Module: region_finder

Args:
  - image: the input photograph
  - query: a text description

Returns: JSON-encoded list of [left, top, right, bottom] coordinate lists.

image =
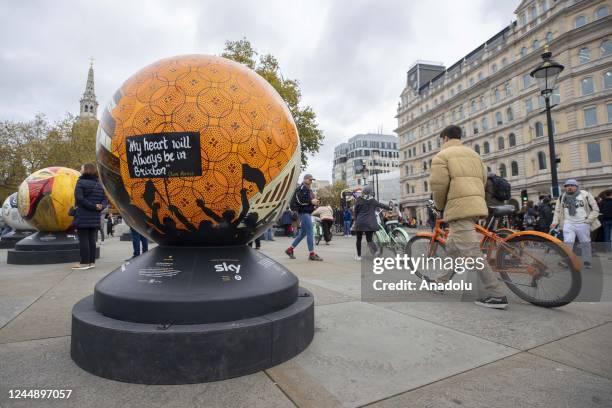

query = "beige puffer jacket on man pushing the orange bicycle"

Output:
[[429, 139, 488, 222]]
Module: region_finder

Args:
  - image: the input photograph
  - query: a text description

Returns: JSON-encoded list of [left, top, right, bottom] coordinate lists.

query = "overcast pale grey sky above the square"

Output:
[[0, 0, 519, 179]]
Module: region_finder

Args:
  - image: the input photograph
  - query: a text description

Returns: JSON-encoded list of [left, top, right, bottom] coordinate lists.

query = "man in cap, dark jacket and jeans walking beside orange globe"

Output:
[[285, 174, 323, 261]]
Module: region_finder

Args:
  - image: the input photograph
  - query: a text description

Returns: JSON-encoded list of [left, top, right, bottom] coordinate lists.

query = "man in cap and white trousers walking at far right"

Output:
[[551, 179, 601, 269]]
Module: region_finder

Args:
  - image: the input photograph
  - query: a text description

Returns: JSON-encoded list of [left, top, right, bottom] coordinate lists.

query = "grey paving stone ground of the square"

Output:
[[0, 233, 612, 408]]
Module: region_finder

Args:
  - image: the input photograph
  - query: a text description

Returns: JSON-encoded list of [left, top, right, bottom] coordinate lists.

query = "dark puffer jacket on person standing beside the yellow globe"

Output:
[[72, 174, 108, 229]]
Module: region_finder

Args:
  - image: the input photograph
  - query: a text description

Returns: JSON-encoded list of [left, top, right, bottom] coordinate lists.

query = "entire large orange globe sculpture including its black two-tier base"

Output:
[[72, 55, 314, 384]]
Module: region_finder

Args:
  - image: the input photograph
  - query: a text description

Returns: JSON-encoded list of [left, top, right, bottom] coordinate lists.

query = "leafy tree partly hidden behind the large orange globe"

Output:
[[221, 38, 324, 168]]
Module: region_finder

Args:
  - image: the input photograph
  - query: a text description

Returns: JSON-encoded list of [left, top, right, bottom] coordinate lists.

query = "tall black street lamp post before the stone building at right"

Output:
[[530, 46, 564, 198]]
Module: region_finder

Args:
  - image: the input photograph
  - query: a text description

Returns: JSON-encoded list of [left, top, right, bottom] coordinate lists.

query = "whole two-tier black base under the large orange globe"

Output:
[[71, 245, 314, 384]]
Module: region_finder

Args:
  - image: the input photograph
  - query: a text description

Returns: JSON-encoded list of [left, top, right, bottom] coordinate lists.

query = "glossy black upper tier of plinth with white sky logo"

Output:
[[94, 245, 298, 324]]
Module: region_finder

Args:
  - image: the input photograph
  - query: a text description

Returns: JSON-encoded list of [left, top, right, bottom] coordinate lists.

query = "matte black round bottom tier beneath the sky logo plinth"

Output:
[[70, 289, 314, 384]]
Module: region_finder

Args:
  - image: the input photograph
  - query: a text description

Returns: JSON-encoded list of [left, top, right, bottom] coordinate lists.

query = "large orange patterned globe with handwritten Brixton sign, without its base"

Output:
[[97, 55, 301, 246]]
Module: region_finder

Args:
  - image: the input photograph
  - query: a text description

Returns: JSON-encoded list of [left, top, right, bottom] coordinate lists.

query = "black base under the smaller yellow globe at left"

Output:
[[6, 231, 100, 265]]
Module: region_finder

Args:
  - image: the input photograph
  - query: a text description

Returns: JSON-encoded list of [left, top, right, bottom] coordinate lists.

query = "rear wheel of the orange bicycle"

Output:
[[495, 234, 582, 307]]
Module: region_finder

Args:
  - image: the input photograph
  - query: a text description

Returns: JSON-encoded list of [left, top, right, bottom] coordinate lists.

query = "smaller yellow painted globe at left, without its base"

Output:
[[17, 167, 81, 232]]
